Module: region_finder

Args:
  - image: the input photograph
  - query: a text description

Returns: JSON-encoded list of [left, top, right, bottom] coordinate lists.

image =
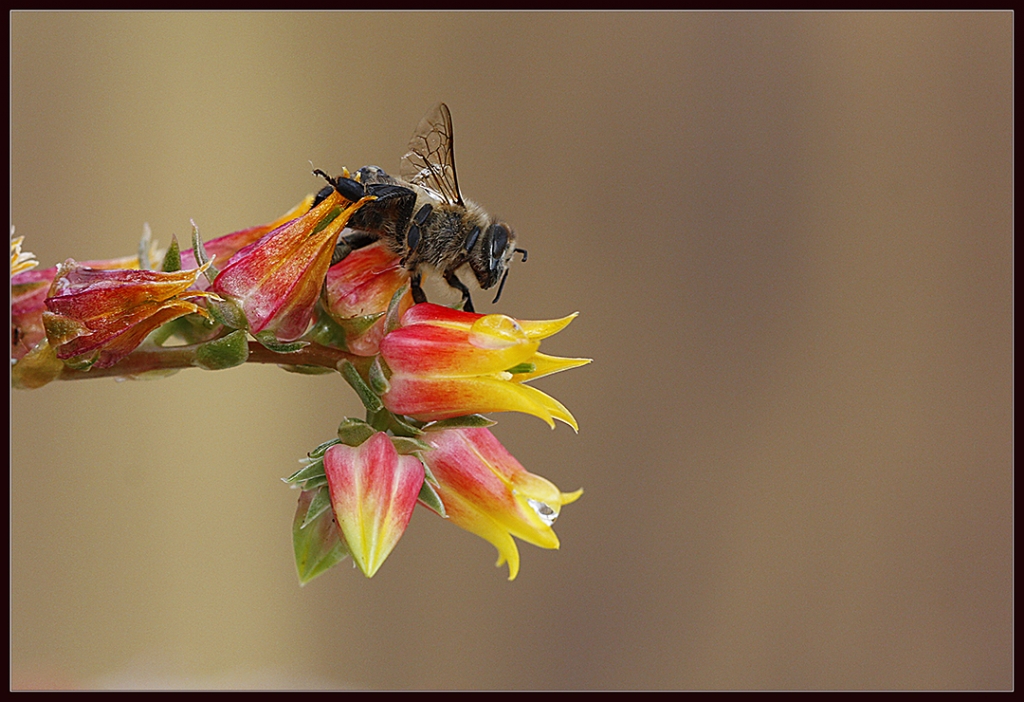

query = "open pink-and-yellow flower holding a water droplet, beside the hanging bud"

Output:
[[421, 427, 583, 580]]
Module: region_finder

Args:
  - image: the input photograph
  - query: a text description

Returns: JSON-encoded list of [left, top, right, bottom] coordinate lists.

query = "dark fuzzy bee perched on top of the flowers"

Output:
[[313, 102, 526, 312]]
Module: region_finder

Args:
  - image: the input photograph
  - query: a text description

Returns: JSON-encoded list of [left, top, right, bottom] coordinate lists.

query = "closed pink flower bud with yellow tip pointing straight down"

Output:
[[324, 432, 425, 577]]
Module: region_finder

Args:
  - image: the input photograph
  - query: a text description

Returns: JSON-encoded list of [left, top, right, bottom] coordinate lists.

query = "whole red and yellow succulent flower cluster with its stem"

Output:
[[11, 180, 589, 583]]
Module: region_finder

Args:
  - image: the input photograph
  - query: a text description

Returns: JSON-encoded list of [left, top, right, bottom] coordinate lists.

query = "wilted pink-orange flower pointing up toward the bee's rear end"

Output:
[[210, 191, 365, 343]]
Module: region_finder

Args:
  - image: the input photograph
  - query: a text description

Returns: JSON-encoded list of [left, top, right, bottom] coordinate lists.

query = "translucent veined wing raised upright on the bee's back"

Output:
[[400, 102, 464, 206]]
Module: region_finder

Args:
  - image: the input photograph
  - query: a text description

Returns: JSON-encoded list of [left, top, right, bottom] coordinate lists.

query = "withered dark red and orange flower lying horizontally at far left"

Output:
[[42, 259, 217, 368]]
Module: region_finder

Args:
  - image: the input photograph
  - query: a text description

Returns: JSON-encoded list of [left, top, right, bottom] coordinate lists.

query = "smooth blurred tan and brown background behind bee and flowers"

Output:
[[10, 12, 1014, 689]]
